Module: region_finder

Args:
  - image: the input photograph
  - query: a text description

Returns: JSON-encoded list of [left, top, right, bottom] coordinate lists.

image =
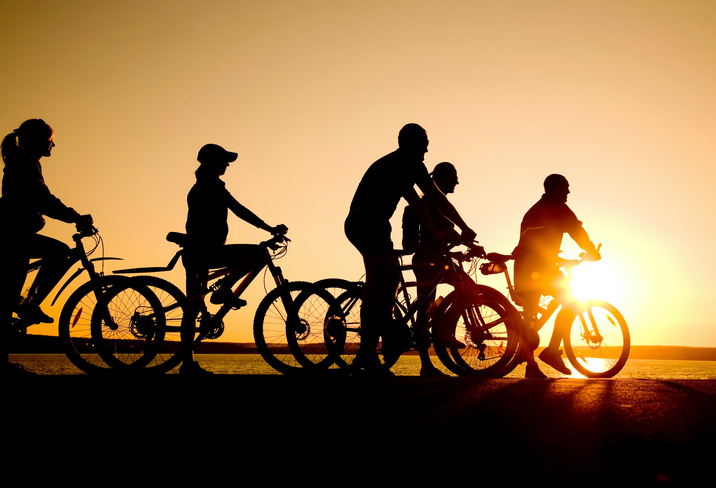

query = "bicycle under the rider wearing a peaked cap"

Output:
[[107, 232, 338, 374]]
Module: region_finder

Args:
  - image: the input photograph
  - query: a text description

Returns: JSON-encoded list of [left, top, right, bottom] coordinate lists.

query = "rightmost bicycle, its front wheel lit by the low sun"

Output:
[[480, 244, 631, 378]]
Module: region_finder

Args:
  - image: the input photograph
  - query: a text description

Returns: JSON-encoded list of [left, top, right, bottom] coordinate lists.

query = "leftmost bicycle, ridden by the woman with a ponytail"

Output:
[[13, 224, 165, 373]]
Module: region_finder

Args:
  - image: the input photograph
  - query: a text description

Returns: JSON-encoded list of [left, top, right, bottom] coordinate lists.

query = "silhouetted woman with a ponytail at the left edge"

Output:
[[0, 119, 92, 374]]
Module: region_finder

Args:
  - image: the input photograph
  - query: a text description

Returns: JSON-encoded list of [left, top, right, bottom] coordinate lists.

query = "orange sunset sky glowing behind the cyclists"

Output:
[[0, 0, 716, 347]]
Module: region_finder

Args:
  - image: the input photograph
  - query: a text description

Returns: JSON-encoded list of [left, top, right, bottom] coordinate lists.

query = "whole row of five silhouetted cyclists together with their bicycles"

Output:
[[0, 119, 630, 378]]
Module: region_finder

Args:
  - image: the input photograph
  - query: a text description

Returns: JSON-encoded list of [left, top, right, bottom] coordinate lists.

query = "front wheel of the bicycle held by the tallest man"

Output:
[[433, 285, 518, 378]]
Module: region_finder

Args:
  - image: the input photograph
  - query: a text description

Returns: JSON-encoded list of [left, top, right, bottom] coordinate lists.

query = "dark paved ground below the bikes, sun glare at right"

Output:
[[2, 375, 716, 487]]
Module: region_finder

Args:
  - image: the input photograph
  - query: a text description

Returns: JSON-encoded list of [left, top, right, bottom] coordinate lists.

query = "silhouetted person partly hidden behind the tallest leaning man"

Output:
[[403, 162, 458, 376]]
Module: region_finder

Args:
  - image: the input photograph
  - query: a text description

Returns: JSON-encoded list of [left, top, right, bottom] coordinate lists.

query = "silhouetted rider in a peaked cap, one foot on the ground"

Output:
[[180, 144, 288, 374]]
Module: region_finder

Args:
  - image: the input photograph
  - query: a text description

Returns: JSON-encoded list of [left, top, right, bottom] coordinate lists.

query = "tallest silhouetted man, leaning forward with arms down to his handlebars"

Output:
[[345, 124, 475, 375]]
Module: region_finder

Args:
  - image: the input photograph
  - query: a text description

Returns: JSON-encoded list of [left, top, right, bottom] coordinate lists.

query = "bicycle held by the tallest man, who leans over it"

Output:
[[296, 241, 518, 377]]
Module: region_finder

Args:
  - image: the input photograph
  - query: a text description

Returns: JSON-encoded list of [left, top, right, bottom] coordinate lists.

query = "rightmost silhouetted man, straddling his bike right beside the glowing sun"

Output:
[[512, 174, 601, 378]]
